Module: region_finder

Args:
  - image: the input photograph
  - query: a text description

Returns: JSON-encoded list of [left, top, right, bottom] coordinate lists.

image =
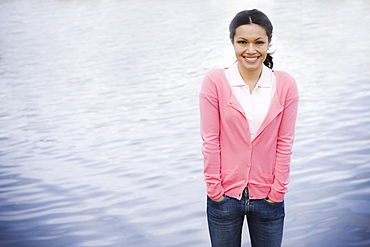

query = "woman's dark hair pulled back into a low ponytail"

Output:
[[229, 9, 274, 69]]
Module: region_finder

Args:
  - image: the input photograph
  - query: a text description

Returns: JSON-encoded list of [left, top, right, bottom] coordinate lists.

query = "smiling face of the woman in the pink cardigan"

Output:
[[233, 24, 270, 73]]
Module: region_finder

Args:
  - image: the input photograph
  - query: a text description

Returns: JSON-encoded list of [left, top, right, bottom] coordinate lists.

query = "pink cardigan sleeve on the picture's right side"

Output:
[[268, 76, 298, 202]]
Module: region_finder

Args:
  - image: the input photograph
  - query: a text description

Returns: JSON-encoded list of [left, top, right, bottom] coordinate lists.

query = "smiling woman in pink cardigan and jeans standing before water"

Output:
[[200, 9, 298, 247]]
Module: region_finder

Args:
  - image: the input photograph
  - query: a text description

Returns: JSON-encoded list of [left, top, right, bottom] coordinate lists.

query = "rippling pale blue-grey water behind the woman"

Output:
[[0, 0, 370, 247]]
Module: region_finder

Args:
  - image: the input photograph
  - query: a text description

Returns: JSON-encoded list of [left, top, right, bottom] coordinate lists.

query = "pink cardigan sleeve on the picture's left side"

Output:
[[199, 72, 224, 199]]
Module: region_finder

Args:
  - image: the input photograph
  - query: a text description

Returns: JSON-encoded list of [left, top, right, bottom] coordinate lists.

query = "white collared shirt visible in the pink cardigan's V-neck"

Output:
[[225, 62, 276, 141]]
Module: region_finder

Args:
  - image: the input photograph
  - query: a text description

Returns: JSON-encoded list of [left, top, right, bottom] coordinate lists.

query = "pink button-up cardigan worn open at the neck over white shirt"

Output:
[[200, 69, 298, 202]]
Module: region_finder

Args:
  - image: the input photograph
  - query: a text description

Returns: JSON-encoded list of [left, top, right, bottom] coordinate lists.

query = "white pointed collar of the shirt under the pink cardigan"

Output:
[[229, 62, 273, 88]]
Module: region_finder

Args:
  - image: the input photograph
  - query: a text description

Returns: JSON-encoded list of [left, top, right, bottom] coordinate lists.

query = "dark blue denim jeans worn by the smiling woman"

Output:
[[207, 189, 285, 247]]
